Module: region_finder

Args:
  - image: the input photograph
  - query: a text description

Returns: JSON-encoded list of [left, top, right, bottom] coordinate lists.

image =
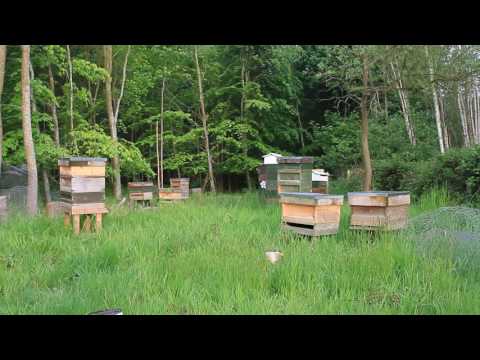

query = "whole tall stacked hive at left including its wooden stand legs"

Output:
[[58, 157, 108, 235]]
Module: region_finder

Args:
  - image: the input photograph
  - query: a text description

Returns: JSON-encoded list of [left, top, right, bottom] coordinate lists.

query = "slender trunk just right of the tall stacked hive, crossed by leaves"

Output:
[[103, 45, 122, 200]]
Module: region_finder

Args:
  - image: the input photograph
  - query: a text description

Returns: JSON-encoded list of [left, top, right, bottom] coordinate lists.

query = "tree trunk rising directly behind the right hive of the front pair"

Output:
[[360, 55, 372, 191]]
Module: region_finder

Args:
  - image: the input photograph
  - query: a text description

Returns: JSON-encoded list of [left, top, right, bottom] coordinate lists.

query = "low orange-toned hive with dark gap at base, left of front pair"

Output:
[[280, 192, 343, 236]]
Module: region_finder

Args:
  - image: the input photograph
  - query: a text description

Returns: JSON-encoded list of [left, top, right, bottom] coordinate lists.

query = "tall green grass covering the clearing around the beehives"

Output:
[[0, 190, 480, 314]]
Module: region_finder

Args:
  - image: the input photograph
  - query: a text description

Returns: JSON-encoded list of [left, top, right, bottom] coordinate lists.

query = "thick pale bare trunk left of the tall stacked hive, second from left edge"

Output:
[[21, 45, 38, 216]]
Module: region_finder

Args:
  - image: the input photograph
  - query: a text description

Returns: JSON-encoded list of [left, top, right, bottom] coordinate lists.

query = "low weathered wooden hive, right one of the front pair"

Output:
[[348, 191, 410, 230]]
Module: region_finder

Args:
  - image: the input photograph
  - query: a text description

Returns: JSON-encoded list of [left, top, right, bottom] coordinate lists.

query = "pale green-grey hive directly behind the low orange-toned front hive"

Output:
[[277, 156, 313, 193]]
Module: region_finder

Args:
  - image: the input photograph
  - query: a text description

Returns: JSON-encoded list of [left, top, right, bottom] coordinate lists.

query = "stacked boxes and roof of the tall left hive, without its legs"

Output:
[[58, 157, 107, 215]]
